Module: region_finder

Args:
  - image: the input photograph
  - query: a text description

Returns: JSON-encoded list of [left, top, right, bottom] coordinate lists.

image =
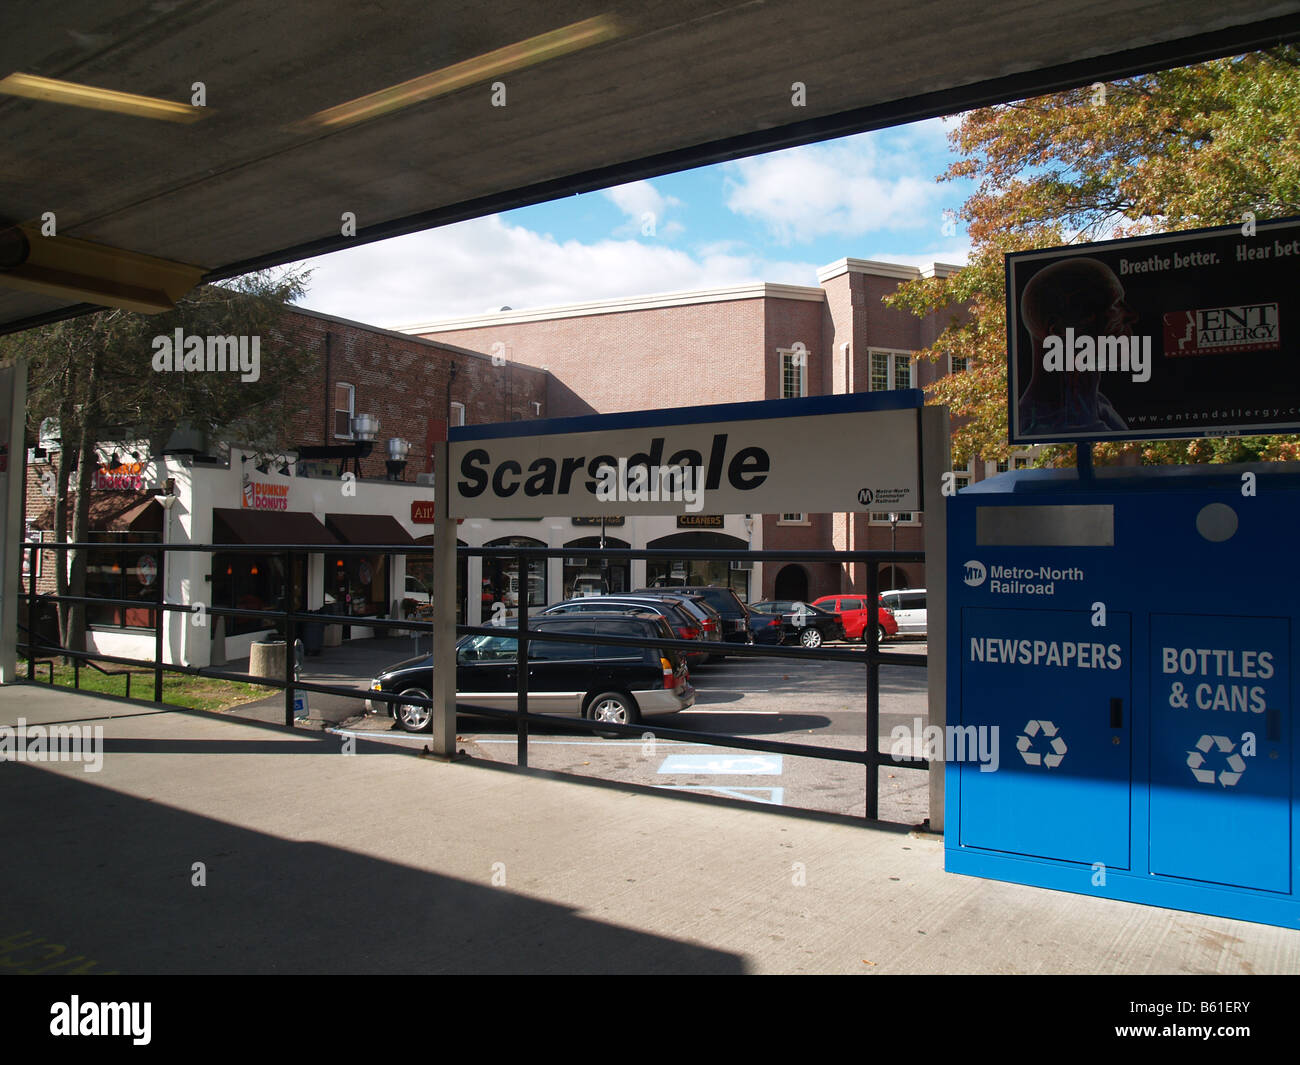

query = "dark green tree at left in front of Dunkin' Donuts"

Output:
[[0, 270, 313, 650]]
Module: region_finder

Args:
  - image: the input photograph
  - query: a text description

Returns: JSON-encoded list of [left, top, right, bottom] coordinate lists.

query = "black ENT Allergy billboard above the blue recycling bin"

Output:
[[1006, 218, 1300, 445]]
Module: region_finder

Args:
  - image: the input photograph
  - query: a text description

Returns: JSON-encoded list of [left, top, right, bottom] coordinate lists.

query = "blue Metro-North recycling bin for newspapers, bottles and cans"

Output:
[[945, 463, 1300, 927]]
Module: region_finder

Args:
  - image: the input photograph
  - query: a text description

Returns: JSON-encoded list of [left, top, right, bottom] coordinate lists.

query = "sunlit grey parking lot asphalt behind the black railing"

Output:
[[229, 638, 930, 826]]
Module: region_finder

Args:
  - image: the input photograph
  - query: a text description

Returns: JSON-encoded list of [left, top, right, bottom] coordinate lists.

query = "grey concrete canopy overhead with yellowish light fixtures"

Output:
[[0, 0, 1300, 332]]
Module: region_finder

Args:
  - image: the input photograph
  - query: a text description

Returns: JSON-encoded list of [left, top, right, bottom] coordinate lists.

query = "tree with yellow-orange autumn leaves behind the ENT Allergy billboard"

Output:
[[887, 47, 1300, 464]]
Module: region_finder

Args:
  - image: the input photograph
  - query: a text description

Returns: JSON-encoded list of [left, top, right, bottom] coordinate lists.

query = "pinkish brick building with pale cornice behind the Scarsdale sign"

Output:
[[403, 259, 983, 599]]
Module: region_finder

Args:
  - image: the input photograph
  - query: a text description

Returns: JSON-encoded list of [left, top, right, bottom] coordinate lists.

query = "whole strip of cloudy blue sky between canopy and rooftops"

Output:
[[289, 112, 971, 328]]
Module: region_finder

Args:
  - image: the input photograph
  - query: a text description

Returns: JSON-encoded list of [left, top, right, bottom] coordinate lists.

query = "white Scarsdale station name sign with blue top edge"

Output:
[[450, 390, 922, 518]]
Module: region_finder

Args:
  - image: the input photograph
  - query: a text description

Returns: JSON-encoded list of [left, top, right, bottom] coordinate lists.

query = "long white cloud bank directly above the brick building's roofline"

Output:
[[293, 215, 816, 328]]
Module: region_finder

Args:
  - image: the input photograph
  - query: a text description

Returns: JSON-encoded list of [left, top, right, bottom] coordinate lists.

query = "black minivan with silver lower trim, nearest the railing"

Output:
[[365, 614, 696, 732]]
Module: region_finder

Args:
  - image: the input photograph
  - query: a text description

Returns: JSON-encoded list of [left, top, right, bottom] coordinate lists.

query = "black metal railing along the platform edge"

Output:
[[20, 542, 931, 819]]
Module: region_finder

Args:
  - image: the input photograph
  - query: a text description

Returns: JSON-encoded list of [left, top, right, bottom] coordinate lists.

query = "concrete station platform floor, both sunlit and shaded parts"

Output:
[[0, 684, 1300, 973]]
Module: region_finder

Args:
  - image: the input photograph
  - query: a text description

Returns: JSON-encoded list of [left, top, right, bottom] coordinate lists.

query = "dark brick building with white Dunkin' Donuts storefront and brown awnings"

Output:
[[23, 309, 547, 666]]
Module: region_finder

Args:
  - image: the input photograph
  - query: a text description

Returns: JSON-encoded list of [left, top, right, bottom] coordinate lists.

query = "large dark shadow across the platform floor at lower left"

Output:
[[0, 764, 744, 974]]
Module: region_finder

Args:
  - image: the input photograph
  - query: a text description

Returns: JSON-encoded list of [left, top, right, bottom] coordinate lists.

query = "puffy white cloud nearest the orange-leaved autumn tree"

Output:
[[727, 133, 952, 242]]
